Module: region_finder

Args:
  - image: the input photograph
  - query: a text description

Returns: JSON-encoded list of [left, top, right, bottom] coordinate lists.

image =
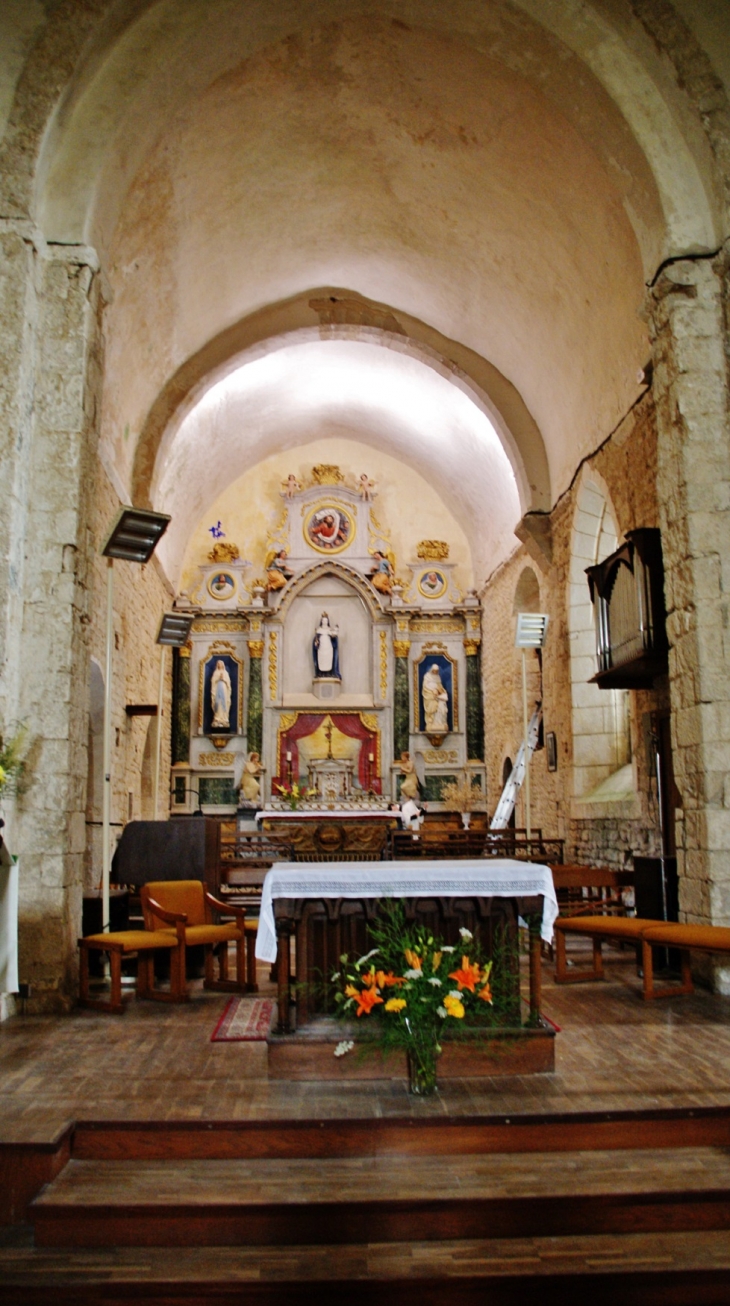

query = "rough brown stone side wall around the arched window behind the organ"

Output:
[[483, 393, 669, 867]]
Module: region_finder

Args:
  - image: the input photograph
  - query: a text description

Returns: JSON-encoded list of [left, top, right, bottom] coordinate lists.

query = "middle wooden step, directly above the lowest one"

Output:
[[31, 1148, 730, 1247]]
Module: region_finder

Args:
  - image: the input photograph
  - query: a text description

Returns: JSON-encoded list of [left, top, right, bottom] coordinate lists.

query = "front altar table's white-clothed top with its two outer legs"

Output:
[[256, 858, 558, 1030]]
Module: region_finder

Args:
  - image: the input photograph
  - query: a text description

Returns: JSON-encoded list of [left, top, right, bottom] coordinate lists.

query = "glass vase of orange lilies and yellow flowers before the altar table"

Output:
[[332, 902, 495, 1094]]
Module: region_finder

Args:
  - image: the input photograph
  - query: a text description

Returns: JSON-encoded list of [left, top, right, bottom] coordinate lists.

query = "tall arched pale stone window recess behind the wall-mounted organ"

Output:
[[568, 469, 631, 798]]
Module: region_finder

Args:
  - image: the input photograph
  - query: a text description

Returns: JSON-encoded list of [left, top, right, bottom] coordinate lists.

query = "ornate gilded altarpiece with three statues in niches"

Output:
[[170, 464, 486, 814]]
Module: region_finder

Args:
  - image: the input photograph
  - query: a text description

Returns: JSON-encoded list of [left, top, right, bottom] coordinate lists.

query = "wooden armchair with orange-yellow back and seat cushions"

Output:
[[140, 880, 246, 993]]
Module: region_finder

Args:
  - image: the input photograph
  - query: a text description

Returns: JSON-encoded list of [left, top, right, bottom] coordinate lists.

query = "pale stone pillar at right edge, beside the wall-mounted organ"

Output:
[[648, 246, 730, 961]]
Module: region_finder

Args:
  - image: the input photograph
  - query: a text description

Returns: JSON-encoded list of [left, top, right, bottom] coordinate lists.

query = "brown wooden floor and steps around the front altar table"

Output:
[[0, 949, 730, 1306]]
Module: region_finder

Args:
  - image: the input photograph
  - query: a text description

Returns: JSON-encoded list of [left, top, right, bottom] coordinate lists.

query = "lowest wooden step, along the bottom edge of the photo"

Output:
[[0, 1232, 730, 1306]]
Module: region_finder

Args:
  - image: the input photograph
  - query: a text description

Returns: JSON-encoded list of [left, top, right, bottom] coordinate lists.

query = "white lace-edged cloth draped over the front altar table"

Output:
[[256, 857, 558, 963]]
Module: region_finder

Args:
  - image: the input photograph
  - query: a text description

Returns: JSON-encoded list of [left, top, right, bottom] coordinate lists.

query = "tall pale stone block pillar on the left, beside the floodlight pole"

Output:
[[4, 237, 102, 1010]]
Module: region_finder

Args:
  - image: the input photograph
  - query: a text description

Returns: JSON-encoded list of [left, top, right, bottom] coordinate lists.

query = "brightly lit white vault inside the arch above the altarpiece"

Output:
[[153, 340, 520, 585]]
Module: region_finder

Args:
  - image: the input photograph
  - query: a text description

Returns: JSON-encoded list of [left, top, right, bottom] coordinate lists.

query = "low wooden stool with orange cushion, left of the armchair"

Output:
[[78, 926, 188, 1015]]
